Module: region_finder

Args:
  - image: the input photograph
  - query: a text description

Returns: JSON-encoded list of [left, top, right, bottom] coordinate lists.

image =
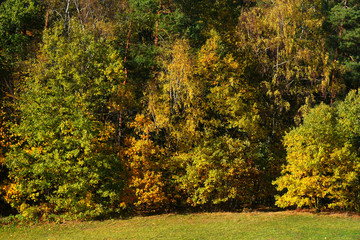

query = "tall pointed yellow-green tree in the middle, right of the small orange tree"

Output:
[[174, 31, 262, 208]]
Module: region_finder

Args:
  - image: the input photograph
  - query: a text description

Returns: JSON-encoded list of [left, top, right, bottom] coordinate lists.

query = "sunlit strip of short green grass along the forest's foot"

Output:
[[0, 212, 360, 240]]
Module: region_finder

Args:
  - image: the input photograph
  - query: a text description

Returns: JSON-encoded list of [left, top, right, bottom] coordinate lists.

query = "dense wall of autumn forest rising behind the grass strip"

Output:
[[0, 0, 360, 220]]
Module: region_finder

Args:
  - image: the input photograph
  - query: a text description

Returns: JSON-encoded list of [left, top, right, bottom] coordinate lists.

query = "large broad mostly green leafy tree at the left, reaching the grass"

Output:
[[6, 20, 124, 217]]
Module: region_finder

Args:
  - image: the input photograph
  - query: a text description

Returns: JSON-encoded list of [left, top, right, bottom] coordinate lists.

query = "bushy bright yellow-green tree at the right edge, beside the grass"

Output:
[[274, 91, 360, 211]]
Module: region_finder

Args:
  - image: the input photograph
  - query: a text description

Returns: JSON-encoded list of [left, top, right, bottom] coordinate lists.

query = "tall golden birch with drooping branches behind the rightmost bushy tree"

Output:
[[238, 0, 343, 142]]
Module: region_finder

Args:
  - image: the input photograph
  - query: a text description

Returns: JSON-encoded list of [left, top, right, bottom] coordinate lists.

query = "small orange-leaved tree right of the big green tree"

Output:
[[123, 114, 175, 212]]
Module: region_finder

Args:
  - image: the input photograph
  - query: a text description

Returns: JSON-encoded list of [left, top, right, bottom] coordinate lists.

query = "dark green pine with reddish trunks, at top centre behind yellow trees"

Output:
[[117, 0, 185, 95]]
